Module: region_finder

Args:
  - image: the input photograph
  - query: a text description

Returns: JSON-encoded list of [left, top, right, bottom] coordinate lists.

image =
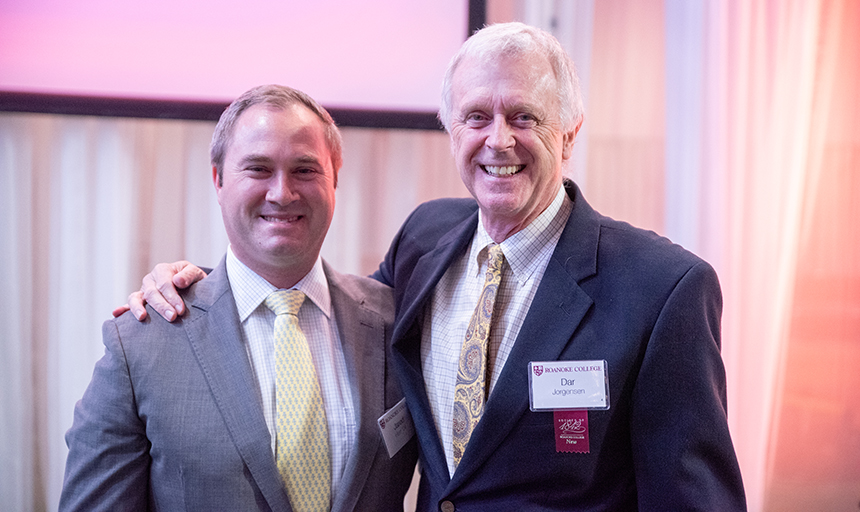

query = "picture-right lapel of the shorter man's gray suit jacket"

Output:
[[324, 263, 385, 510]]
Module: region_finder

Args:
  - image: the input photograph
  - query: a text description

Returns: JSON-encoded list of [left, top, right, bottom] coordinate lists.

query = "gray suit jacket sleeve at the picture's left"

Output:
[[59, 320, 151, 511]]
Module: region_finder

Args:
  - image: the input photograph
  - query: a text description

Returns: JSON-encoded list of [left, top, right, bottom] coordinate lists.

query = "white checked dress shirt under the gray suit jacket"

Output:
[[227, 248, 356, 502]]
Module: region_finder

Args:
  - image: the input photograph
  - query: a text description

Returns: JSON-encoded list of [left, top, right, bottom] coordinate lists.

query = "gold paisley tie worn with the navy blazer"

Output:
[[454, 244, 505, 468]]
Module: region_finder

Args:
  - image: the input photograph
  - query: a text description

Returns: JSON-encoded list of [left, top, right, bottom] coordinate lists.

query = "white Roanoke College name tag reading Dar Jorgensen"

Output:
[[529, 361, 609, 411]]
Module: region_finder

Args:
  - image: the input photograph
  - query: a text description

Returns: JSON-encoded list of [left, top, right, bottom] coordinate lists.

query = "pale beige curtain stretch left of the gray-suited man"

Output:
[[0, 114, 232, 510]]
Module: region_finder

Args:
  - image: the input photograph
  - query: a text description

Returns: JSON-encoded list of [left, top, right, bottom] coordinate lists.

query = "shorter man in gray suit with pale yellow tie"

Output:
[[60, 85, 417, 512]]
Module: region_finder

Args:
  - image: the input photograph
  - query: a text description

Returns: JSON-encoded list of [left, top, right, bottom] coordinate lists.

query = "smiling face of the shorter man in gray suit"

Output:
[[212, 104, 335, 288]]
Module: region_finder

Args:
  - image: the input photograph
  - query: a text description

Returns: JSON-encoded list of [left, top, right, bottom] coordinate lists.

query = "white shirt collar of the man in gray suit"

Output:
[[227, 246, 331, 322]]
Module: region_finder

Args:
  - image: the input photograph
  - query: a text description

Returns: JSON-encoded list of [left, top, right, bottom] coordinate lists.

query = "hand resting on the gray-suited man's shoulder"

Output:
[[113, 260, 206, 322]]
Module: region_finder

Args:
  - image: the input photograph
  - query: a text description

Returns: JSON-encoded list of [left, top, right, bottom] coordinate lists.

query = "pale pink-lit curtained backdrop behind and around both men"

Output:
[[0, 0, 860, 511]]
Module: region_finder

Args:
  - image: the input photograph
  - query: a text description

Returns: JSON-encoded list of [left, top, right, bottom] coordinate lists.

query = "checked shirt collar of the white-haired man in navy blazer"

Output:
[[469, 186, 573, 286]]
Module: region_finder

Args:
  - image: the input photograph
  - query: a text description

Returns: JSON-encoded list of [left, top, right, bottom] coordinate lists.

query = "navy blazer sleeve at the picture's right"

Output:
[[630, 262, 746, 511]]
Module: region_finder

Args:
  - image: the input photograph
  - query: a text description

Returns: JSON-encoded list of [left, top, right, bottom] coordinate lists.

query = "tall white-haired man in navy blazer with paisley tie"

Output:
[[122, 23, 746, 512]]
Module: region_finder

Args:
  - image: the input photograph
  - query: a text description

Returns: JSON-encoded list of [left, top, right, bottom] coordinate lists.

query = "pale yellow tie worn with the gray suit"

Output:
[[266, 290, 331, 512]]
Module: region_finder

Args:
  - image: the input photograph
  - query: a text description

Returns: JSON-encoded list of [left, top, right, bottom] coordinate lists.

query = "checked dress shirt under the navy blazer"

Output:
[[421, 187, 573, 475]]
